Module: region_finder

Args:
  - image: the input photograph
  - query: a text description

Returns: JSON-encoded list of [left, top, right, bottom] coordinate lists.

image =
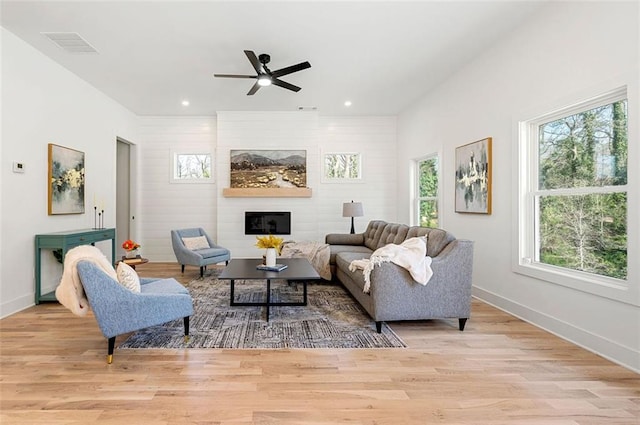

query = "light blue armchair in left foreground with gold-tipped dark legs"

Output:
[[76, 261, 193, 363]]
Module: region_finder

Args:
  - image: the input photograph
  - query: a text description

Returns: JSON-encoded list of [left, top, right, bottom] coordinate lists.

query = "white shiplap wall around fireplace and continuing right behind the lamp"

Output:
[[216, 112, 397, 258]]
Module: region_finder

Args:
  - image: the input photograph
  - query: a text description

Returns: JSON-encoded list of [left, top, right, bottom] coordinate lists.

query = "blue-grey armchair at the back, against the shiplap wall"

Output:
[[171, 227, 231, 277]]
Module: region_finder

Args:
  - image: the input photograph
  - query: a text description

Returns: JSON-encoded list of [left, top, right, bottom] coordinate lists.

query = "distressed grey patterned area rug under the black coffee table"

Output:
[[119, 275, 406, 349]]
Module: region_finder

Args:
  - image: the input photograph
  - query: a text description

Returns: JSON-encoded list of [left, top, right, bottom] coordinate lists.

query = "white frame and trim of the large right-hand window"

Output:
[[512, 86, 640, 305]]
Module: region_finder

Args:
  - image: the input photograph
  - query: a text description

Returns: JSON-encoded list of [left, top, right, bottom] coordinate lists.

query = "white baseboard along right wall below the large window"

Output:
[[471, 286, 640, 373]]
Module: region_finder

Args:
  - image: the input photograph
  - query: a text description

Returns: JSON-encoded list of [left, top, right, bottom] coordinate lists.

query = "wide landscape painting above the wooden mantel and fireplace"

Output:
[[230, 150, 307, 189]]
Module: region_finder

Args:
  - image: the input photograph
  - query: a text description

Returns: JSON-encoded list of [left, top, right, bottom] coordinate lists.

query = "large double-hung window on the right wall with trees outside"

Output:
[[520, 90, 628, 285]]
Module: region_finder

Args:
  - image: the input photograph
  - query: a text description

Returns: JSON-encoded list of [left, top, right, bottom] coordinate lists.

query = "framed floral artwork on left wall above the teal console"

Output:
[[47, 143, 84, 215]]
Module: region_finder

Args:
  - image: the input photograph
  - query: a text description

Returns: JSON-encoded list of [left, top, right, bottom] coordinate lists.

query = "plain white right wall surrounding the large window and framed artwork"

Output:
[[398, 2, 640, 370]]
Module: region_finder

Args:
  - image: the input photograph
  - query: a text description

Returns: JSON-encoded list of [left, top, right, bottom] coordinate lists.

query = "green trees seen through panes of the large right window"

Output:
[[534, 99, 627, 279]]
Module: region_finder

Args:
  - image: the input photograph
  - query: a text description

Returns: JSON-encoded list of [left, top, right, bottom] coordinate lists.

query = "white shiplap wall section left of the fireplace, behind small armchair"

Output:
[[135, 117, 218, 261]]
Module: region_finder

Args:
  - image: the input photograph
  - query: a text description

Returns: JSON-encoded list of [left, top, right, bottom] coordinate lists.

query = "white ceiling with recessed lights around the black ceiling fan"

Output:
[[0, 0, 543, 115]]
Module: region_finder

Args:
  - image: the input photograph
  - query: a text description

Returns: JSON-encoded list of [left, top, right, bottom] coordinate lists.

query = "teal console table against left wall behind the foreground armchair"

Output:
[[36, 229, 116, 304]]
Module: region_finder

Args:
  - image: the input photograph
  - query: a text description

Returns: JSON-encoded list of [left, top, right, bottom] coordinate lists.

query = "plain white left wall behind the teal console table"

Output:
[[0, 29, 137, 317]]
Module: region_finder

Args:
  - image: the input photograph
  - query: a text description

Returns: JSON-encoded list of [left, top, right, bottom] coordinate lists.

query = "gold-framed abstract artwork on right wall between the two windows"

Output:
[[455, 137, 492, 214]]
